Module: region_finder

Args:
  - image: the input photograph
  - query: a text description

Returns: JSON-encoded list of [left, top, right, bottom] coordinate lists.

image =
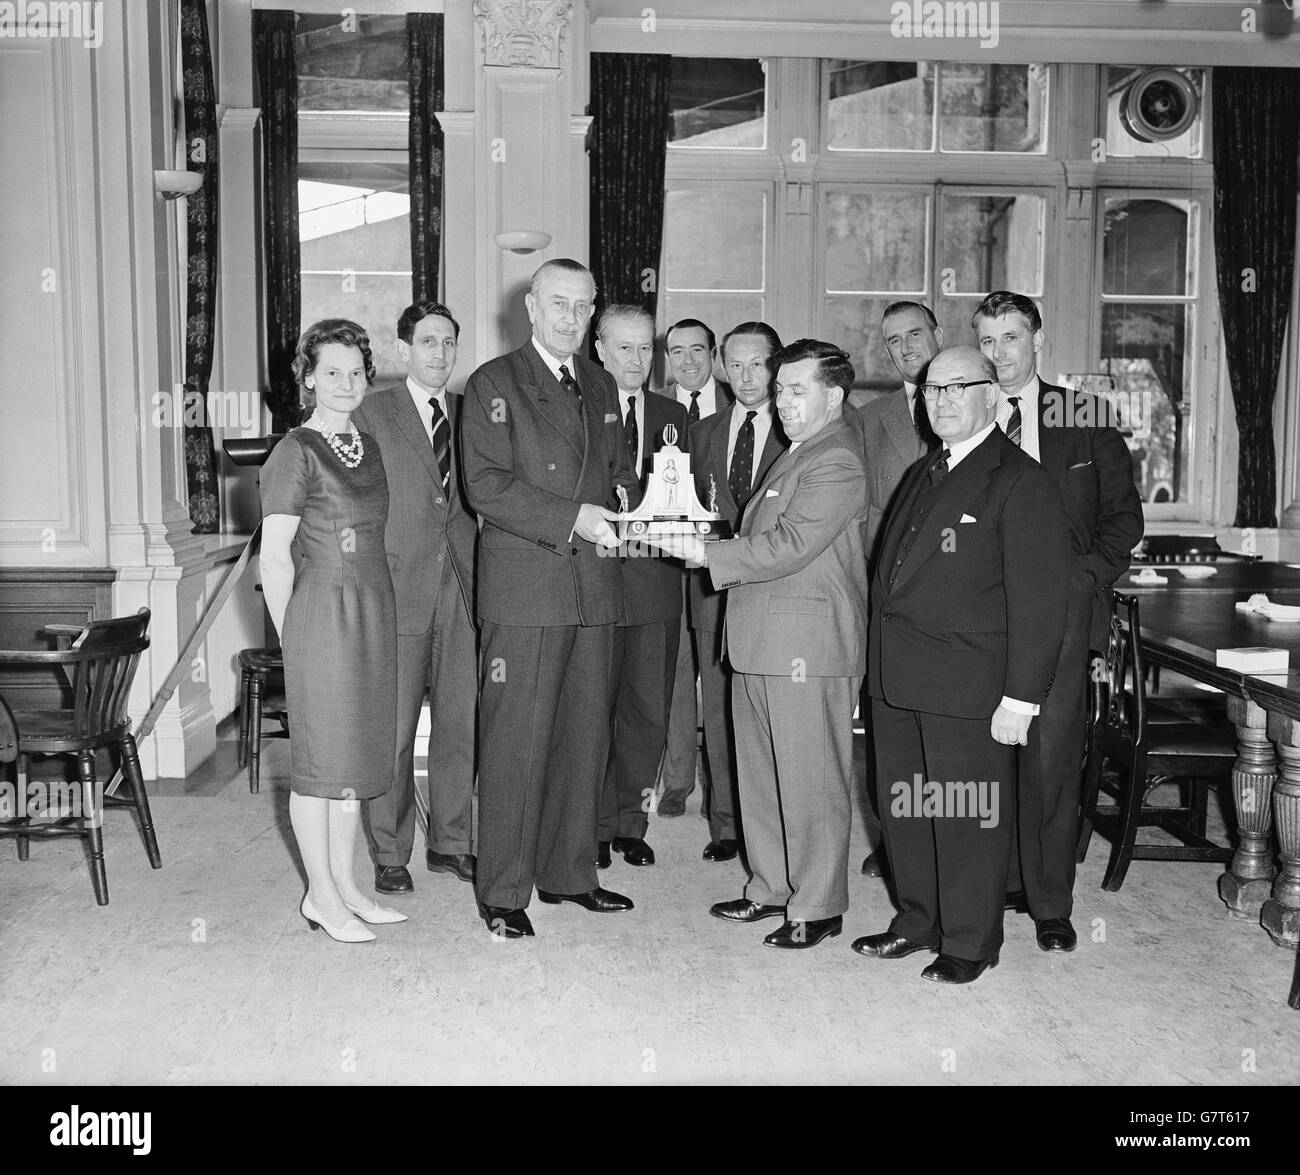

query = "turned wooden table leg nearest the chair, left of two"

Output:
[[1219, 695, 1278, 919]]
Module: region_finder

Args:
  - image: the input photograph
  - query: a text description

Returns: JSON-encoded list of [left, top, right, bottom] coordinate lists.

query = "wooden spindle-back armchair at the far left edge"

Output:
[[0, 608, 163, 906]]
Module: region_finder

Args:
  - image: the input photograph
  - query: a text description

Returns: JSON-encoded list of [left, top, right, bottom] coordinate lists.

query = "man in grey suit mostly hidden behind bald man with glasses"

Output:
[[850, 302, 944, 877]]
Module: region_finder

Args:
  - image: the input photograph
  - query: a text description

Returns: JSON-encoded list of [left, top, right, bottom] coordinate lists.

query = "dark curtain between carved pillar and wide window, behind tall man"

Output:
[[588, 53, 672, 315]]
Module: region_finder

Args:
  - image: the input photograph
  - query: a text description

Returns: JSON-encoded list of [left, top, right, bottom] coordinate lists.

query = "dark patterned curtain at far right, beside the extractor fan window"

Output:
[[1212, 66, 1300, 526]]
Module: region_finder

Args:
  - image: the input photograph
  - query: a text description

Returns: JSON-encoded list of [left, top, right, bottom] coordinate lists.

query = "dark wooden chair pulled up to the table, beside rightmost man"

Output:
[[1076, 591, 1236, 893]]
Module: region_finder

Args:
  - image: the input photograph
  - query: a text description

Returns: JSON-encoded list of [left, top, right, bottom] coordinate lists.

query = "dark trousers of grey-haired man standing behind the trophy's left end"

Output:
[[599, 616, 681, 841]]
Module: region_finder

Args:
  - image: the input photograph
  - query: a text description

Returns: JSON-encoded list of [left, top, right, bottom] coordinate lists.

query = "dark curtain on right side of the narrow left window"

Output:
[[407, 12, 442, 302]]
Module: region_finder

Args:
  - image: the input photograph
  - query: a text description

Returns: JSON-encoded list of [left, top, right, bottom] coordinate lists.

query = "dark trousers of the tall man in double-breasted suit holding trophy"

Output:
[[476, 621, 614, 910]]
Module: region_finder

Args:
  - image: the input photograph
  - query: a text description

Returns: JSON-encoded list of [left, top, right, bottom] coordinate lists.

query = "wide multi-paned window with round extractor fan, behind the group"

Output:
[[659, 58, 1217, 517]]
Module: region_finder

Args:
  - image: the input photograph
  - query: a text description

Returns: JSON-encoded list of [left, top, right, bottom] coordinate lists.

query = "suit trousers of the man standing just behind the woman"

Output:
[[365, 559, 478, 864]]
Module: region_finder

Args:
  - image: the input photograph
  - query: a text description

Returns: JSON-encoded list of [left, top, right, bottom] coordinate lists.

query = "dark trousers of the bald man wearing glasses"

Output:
[[871, 698, 1015, 959]]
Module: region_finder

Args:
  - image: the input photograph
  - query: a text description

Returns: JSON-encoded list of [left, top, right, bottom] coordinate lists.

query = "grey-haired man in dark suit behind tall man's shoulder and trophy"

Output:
[[595, 305, 688, 868]]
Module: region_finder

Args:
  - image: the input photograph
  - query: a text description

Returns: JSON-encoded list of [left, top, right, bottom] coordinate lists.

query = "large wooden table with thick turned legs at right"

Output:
[[1115, 563, 1300, 1007]]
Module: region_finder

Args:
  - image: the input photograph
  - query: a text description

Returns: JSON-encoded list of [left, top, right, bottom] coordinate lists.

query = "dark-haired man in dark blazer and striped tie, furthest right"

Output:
[[972, 290, 1144, 950]]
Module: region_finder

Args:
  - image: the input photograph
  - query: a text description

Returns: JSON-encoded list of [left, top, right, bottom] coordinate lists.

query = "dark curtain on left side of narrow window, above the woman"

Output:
[[252, 9, 303, 433]]
